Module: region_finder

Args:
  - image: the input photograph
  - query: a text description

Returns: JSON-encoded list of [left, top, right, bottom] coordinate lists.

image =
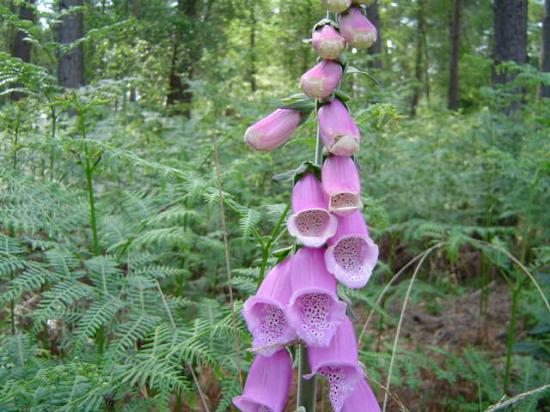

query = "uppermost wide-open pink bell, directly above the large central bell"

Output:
[[287, 173, 337, 247]]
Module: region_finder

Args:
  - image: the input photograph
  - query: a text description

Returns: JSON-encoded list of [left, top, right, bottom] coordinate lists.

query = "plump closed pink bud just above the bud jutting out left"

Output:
[[300, 60, 343, 99]]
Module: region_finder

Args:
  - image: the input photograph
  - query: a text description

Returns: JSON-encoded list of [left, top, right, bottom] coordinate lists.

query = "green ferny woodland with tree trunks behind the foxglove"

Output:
[[0, 0, 550, 412]]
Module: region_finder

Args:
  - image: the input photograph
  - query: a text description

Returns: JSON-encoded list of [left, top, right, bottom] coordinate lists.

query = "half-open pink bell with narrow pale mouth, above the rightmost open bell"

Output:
[[321, 156, 362, 216]]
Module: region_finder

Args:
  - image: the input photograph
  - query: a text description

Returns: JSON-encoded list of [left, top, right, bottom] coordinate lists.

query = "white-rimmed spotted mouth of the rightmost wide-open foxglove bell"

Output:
[[325, 234, 378, 289]]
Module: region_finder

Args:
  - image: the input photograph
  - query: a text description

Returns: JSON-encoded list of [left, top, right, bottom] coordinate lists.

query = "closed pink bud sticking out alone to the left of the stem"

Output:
[[244, 109, 301, 152]]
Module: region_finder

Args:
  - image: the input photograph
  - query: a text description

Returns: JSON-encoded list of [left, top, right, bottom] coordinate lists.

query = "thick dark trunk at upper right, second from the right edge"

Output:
[[493, 0, 527, 84]]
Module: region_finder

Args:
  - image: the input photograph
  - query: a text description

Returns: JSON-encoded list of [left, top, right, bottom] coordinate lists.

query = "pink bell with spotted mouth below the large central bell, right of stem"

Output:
[[304, 317, 364, 412]]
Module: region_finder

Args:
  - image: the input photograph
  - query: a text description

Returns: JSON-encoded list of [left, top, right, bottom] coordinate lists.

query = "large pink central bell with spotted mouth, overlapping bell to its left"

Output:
[[287, 248, 346, 347]]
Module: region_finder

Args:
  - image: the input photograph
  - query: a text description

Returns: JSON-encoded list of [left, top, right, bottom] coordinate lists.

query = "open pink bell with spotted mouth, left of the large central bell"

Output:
[[242, 258, 296, 356]]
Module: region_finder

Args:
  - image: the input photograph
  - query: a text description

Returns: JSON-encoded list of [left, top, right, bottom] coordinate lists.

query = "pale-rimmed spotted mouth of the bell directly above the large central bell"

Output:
[[288, 208, 338, 247]]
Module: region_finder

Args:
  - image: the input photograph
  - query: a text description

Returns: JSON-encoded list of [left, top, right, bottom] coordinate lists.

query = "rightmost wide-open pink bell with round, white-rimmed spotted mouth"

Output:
[[325, 211, 378, 289]]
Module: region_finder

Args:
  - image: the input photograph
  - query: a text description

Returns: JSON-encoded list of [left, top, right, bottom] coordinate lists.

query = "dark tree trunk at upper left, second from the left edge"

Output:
[[57, 0, 84, 89]]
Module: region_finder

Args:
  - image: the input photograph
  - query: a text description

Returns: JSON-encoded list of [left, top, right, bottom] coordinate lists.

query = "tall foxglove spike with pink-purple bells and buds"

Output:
[[233, 0, 380, 412]]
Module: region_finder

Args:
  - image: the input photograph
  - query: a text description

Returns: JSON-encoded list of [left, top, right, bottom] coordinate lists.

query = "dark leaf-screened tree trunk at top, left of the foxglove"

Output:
[[166, 0, 200, 118]]
